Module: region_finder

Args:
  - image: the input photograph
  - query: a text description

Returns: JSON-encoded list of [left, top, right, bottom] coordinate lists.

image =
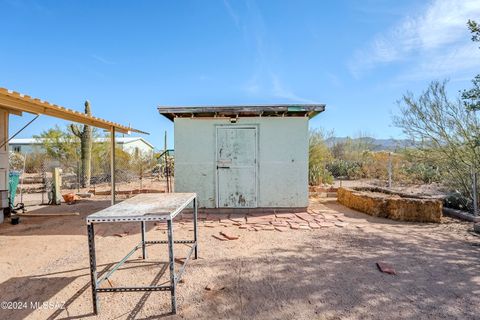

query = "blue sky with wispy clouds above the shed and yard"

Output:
[[0, 0, 480, 149]]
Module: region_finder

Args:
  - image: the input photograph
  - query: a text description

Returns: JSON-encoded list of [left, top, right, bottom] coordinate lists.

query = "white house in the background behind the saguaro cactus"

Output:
[[9, 137, 154, 154]]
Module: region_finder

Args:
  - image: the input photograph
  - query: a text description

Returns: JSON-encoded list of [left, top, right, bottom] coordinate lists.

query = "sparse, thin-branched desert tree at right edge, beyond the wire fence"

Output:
[[394, 81, 480, 199]]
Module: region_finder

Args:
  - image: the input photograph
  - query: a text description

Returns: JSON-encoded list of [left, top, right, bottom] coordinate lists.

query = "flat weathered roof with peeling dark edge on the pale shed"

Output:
[[158, 104, 325, 121]]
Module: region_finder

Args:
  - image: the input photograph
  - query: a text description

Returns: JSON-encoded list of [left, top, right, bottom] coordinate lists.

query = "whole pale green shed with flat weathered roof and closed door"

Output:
[[158, 104, 325, 209]]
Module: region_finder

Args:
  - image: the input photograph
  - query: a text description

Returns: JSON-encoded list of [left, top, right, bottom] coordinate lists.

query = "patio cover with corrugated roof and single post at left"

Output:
[[0, 88, 147, 205]]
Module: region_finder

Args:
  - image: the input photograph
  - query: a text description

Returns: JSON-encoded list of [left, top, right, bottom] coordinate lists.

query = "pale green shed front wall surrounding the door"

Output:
[[174, 117, 308, 208]]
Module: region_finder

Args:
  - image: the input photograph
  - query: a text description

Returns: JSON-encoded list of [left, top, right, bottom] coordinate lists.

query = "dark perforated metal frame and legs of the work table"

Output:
[[87, 194, 198, 314]]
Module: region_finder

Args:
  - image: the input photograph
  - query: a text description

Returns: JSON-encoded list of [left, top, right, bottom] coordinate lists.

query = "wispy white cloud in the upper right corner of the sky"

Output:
[[349, 0, 480, 78]]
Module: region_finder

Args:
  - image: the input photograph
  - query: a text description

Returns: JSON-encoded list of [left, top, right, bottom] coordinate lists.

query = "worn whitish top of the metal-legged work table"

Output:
[[87, 193, 197, 224]]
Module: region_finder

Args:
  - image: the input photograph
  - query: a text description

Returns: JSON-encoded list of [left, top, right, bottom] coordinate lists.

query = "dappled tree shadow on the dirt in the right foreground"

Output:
[[185, 226, 480, 319]]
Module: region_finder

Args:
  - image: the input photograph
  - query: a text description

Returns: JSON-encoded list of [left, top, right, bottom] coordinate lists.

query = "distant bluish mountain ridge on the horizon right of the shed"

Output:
[[325, 137, 415, 151]]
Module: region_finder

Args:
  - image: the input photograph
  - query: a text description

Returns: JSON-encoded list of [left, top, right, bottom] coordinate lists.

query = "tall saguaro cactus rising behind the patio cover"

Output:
[[70, 100, 92, 188]]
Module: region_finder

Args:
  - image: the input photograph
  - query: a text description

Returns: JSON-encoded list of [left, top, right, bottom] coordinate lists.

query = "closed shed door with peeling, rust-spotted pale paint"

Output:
[[216, 127, 257, 208]]
